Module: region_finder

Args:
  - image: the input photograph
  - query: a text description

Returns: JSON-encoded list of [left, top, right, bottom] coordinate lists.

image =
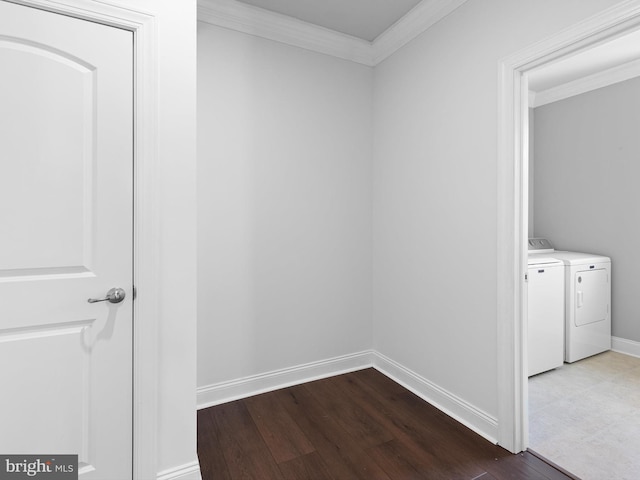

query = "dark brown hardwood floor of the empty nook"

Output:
[[198, 369, 575, 480]]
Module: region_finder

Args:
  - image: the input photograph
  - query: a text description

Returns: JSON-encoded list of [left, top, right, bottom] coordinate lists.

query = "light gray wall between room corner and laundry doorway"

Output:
[[373, 0, 616, 417]]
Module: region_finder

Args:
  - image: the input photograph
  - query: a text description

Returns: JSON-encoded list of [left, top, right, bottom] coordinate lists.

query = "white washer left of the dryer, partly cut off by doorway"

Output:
[[527, 239, 565, 377]]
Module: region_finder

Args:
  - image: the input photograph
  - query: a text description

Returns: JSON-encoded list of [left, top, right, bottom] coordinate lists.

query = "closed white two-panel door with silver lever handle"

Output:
[[0, 1, 133, 480]]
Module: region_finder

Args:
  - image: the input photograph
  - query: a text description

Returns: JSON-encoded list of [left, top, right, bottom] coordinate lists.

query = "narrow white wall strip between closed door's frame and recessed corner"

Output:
[[153, 0, 197, 480]]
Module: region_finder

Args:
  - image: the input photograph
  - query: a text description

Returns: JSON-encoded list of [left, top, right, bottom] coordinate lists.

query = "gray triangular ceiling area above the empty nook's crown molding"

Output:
[[238, 0, 421, 42]]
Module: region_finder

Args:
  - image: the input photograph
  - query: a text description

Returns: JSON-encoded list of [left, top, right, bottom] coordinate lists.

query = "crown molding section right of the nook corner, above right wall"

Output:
[[373, 0, 467, 65]]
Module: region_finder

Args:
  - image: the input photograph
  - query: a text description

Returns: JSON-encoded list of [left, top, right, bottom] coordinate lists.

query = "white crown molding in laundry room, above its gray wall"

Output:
[[531, 60, 640, 107]]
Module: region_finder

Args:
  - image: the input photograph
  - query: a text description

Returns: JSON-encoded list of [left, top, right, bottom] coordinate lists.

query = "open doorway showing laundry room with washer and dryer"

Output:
[[526, 32, 640, 479]]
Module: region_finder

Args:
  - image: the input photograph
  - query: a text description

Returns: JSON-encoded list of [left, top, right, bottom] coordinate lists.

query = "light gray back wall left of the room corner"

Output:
[[198, 22, 372, 387]]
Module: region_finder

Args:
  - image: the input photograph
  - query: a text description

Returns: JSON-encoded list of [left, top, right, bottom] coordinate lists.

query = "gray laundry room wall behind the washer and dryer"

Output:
[[530, 78, 640, 341]]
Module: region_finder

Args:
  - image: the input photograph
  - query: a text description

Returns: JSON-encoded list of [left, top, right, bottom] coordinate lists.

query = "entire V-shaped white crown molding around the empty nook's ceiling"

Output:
[[198, 0, 467, 67]]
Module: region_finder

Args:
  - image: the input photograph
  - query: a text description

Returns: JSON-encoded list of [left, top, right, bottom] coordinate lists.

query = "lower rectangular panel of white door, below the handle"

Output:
[[0, 322, 91, 454]]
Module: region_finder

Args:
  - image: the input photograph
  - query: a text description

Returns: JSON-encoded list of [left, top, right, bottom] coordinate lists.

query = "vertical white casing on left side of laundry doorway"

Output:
[[497, 47, 528, 453]]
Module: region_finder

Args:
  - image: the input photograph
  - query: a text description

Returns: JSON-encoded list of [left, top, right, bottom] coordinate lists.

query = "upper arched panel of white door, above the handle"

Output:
[[0, 38, 96, 274]]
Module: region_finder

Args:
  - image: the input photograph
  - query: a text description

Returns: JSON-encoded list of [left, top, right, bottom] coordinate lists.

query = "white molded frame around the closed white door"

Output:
[[5, 0, 160, 480]]
